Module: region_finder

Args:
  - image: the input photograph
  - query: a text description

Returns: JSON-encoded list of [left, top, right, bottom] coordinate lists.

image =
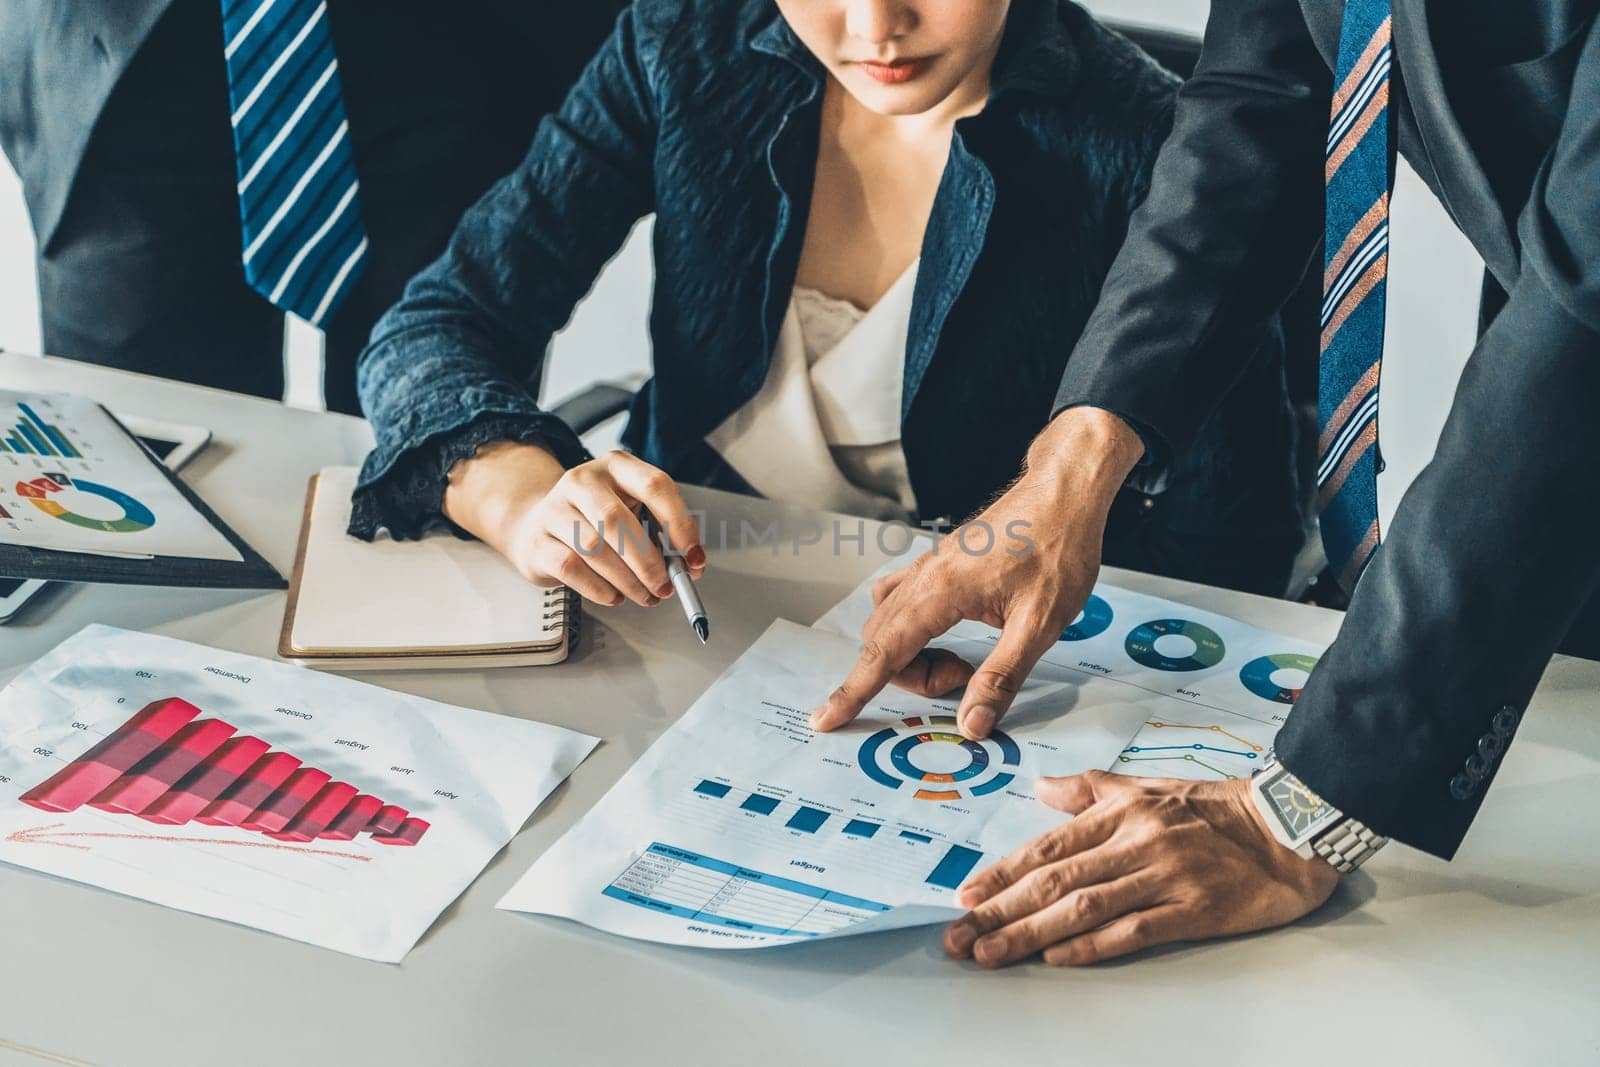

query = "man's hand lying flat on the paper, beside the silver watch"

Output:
[[944, 771, 1339, 968]]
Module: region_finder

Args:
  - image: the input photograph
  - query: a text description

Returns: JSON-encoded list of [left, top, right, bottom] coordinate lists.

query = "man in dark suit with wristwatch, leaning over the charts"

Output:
[[814, 0, 1600, 966]]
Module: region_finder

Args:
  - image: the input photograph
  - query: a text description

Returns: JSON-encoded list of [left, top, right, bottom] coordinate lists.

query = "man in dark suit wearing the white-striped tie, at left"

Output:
[[0, 0, 622, 411]]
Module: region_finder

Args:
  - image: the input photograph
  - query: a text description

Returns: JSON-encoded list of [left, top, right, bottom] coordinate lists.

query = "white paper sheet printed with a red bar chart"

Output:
[[0, 625, 597, 963]]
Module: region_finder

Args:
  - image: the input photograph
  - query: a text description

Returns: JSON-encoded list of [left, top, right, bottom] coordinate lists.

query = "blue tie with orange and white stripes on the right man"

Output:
[[1317, 0, 1390, 590]]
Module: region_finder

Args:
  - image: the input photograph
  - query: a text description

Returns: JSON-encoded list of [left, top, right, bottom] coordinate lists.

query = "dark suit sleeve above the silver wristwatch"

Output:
[[1277, 16, 1600, 857]]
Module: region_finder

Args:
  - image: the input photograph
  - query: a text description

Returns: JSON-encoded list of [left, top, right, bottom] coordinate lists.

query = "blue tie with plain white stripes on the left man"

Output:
[[222, 0, 366, 326]]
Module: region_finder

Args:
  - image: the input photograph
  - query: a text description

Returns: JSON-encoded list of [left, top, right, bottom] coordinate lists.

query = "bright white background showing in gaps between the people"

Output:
[[0, 0, 1482, 523]]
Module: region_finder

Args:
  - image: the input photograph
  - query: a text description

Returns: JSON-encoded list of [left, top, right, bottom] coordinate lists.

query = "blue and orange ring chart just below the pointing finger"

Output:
[[856, 715, 1022, 800]]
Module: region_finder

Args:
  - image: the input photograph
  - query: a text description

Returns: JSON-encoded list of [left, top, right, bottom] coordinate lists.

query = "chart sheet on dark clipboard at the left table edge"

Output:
[[0, 389, 243, 561]]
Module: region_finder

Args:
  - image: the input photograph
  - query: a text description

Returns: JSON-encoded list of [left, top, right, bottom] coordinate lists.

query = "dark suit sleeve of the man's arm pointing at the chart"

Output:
[[1054, 0, 1331, 474]]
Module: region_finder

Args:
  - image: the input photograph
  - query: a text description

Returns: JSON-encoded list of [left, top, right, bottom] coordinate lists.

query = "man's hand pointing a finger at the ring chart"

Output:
[[811, 408, 1144, 739]]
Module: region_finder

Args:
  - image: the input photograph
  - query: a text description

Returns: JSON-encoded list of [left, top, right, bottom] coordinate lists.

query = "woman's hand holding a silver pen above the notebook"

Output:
[[445, 442, 706, 606]]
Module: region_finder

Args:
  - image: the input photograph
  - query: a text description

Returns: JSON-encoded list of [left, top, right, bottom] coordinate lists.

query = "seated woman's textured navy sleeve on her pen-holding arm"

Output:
[[357, 3, 667, 536]]
